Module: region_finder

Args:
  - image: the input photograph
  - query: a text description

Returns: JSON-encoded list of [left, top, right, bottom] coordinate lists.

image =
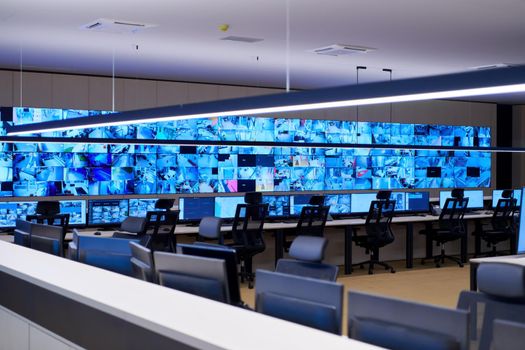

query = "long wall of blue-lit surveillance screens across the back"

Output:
[[0, 108, 491, 197]]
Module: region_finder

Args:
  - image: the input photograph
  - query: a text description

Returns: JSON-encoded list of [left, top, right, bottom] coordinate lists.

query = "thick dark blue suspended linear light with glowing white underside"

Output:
[[7, 66, 525, 136]]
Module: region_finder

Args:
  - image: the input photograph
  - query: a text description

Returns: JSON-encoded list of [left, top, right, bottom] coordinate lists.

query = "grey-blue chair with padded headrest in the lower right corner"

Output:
[[457, 259, 525, 350]]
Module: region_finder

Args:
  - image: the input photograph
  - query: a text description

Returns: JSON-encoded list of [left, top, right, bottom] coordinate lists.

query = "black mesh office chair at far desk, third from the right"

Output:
[[352, 199, 396, 274]]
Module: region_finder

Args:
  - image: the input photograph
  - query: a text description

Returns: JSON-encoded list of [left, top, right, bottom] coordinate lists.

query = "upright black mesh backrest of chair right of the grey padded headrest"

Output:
[[232, 204, 268, 249]]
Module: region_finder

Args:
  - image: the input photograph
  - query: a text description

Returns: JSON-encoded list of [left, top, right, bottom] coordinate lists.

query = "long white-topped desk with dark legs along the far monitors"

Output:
[[61, 213, 492, 274]]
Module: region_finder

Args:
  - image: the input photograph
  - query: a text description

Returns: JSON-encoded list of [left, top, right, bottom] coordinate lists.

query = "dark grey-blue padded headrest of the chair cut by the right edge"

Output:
[[477, 259, 525, 300]]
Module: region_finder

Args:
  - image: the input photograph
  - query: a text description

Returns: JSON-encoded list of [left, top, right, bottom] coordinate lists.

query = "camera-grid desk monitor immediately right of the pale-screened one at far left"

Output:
[[88, 199, 129, 226]]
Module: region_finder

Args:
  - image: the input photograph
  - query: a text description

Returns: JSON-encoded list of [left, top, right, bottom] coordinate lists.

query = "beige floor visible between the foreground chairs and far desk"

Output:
[[241, 261, 470, 334]]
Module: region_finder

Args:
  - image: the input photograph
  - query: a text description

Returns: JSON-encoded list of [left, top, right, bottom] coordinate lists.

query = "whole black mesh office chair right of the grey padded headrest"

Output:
[[228, 204, 268, 288]]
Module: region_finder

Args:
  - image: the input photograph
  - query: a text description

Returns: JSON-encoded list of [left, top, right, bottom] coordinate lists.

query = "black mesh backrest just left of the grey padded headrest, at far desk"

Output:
[[146, 210, 179, 252]]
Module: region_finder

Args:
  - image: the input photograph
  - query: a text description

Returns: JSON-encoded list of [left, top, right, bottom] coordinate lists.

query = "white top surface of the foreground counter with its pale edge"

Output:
[[0, 241, 378, 350]]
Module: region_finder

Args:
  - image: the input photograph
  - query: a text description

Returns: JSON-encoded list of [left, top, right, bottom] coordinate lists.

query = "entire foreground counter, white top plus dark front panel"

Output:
[[0, 241, 378, 350]]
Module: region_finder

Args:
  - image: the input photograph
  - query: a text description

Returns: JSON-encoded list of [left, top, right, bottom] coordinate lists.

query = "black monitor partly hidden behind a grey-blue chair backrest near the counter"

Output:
[[177, 243, 242, 305]]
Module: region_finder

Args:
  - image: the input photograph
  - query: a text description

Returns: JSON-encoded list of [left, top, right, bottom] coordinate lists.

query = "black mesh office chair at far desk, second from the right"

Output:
[[420, 197, 468, 267]]
